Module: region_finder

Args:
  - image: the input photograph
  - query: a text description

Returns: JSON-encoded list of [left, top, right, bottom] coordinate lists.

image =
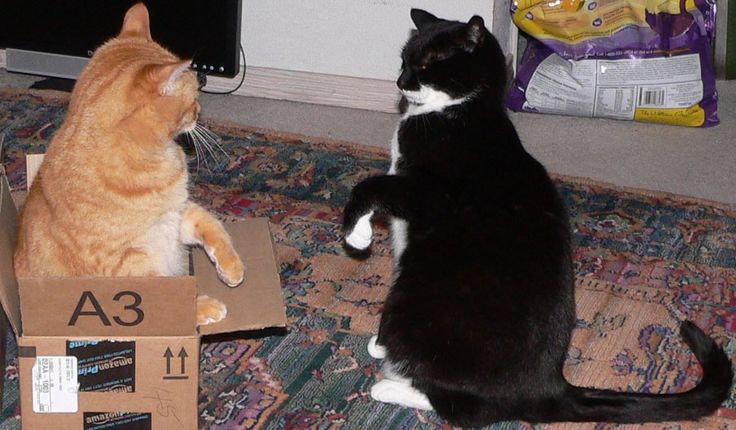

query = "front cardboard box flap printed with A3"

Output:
[[18, 276, 198, 337]]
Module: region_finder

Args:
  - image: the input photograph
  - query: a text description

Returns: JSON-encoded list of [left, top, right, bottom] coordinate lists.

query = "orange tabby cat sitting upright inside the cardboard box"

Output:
[[15, 4, 244, 324]]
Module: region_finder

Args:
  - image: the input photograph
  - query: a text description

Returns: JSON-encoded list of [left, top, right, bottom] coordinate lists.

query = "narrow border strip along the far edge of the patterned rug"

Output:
[[0, 88, 736, 217]]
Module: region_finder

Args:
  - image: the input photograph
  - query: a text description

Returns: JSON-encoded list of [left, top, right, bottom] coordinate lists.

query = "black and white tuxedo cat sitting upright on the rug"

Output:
[[344, 9, 733, 426]]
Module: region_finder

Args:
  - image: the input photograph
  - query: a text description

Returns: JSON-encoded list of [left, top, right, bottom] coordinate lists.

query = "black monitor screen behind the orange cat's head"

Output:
[[0, 0, 242, 77]]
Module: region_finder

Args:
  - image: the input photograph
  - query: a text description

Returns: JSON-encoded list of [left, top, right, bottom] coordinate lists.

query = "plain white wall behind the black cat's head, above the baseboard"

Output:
[[241, 0, 493, 81]]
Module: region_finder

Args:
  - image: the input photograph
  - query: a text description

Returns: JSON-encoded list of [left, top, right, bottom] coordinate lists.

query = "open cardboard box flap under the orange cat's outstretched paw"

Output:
[[194, 218, 286, 335]]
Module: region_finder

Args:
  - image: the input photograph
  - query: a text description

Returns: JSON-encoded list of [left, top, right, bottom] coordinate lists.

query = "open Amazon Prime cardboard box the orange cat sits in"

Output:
[[0, 156, 286, 430]]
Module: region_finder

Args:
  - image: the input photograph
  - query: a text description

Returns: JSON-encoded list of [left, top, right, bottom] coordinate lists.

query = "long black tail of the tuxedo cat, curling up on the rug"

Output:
[[550, 321, 733, 423]]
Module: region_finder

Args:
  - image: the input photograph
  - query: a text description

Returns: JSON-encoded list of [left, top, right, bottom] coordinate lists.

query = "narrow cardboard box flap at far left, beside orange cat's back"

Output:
[[0, 171, 21, 336]]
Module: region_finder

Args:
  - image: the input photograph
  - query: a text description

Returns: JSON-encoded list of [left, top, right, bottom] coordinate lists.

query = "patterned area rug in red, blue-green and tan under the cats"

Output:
[[0, 91, 736, 430]]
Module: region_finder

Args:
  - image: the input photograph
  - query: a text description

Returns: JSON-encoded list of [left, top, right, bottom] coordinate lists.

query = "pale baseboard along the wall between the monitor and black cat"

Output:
[[0, 49, 399, 113]]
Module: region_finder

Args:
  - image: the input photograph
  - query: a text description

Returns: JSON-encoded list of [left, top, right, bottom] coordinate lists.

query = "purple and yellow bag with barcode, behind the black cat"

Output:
[[507, 0, 719, 127]]
